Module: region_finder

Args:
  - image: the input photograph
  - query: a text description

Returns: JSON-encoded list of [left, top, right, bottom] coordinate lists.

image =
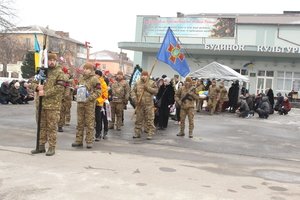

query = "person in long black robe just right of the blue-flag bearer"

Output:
[[155, 77, 175, 130]]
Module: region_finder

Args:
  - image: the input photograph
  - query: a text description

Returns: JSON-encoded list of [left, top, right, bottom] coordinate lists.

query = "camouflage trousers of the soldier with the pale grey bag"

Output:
[[76, 102, 95, 144]]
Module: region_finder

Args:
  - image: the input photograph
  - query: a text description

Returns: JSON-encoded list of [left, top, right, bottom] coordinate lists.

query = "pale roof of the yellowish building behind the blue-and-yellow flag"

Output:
[[7, 25, 84, 45]]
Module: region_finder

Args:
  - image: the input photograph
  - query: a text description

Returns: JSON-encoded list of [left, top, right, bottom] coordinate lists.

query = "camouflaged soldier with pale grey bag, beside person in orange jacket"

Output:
[[72, 63, 101, 149]]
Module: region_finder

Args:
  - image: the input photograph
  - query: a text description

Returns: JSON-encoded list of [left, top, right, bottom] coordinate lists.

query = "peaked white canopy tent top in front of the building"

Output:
[[189, 62, 249, 82]]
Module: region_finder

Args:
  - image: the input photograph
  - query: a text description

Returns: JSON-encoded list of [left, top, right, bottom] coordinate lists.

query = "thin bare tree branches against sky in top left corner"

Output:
[[0, 0, 17, 30]]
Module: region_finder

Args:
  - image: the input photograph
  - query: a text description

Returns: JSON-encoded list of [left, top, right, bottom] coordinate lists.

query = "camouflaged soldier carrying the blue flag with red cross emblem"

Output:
[[131, 71, 158, 140]]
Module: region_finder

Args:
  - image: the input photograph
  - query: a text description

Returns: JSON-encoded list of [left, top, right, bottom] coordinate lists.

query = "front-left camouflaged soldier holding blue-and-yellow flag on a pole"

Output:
[[31, 53, 65, 156]]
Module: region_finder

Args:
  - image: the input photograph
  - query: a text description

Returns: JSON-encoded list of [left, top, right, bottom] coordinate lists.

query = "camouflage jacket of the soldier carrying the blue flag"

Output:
[[131, 80, 158, 106]]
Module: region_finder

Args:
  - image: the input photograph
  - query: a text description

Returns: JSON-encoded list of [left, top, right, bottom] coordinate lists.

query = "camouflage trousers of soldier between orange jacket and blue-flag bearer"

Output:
[[109, 102, 124, 128]]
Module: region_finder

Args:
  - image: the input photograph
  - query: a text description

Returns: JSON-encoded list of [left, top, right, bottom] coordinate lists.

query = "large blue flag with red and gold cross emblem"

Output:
[[156, 27, 190, 77]]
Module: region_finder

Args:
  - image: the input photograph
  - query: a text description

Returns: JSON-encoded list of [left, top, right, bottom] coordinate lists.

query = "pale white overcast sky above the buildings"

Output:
[[13, 0, 300, 58]]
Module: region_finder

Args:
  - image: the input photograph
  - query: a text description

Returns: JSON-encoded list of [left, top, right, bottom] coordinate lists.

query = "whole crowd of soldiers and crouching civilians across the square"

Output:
[[0, 53, 291, 156]]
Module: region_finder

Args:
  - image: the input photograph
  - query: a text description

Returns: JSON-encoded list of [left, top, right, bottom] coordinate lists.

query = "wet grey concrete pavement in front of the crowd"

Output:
[[0, 103, 300, 200]]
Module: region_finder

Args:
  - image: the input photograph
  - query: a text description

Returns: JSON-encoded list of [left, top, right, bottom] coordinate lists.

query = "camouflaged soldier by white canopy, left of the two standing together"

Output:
[[208, 80, 220, 115]]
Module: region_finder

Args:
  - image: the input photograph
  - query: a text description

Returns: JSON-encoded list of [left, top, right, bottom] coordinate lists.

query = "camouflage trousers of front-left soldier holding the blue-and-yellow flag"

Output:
[[40, 109, 60, 147]]
